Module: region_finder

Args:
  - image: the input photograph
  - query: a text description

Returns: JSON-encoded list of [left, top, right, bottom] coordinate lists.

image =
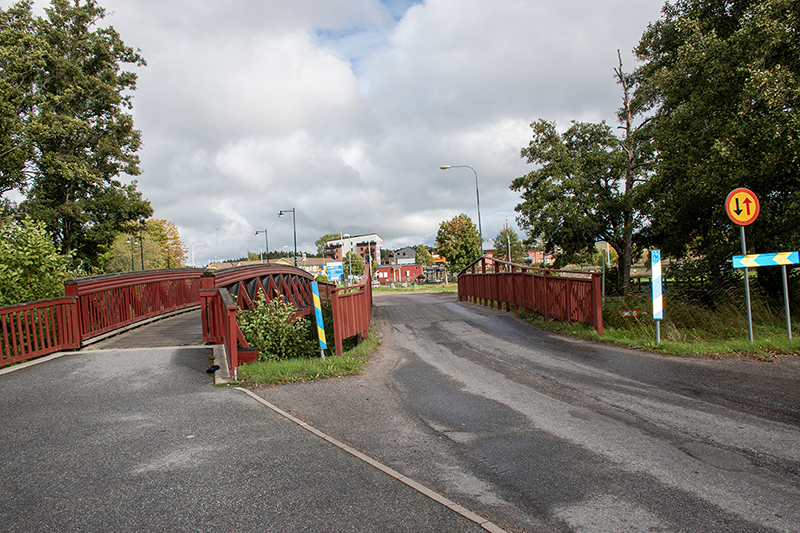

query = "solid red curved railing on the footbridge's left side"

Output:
[[64, 269, 204, 342]]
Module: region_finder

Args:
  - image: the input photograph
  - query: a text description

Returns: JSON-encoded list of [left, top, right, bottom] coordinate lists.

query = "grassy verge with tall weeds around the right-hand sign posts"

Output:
[[521, 295, 800, 361]]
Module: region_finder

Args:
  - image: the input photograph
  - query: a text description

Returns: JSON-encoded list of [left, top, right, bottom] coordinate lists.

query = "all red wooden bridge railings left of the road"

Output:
[[0, 265, 372, 377]]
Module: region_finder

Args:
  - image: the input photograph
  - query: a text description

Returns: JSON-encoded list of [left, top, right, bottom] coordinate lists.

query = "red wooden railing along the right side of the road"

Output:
[[458, 257, 603, 335]]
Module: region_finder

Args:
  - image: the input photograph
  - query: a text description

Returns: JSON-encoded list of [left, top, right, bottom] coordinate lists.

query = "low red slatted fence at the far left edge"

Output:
[[0, 298, 80, 366]]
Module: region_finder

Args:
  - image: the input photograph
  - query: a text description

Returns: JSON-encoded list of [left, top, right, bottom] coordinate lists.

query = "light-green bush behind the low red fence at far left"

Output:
[[0, 213, 70, 305]]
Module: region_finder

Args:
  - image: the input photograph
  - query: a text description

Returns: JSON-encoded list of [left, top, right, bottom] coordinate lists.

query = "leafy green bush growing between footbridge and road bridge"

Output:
[[236, 292, 318, 361]]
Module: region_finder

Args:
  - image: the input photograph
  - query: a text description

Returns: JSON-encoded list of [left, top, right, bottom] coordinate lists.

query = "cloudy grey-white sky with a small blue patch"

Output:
[[29, 0, 664, 264]]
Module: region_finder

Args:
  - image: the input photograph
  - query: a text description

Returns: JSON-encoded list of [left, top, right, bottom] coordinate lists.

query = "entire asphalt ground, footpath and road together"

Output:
[[6, 295, 800, 533]]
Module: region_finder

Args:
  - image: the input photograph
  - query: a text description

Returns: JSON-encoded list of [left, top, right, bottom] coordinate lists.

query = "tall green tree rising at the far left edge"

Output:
[[0, 0, 152, 267]]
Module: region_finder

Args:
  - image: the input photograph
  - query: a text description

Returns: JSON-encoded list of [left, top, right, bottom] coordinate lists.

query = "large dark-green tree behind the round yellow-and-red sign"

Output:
[[635, 0, 800, 284]]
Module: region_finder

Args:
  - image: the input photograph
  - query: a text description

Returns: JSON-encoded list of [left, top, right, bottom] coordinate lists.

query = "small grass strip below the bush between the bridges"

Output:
[[234, 327, 380, 385]]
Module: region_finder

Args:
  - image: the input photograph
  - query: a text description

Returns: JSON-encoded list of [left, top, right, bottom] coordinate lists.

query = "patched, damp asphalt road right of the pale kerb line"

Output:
[[257, 294, 800, 532]]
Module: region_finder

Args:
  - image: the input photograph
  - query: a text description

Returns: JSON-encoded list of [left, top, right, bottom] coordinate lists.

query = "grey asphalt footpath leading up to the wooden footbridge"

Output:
[[0, 330, 499, 532]]
